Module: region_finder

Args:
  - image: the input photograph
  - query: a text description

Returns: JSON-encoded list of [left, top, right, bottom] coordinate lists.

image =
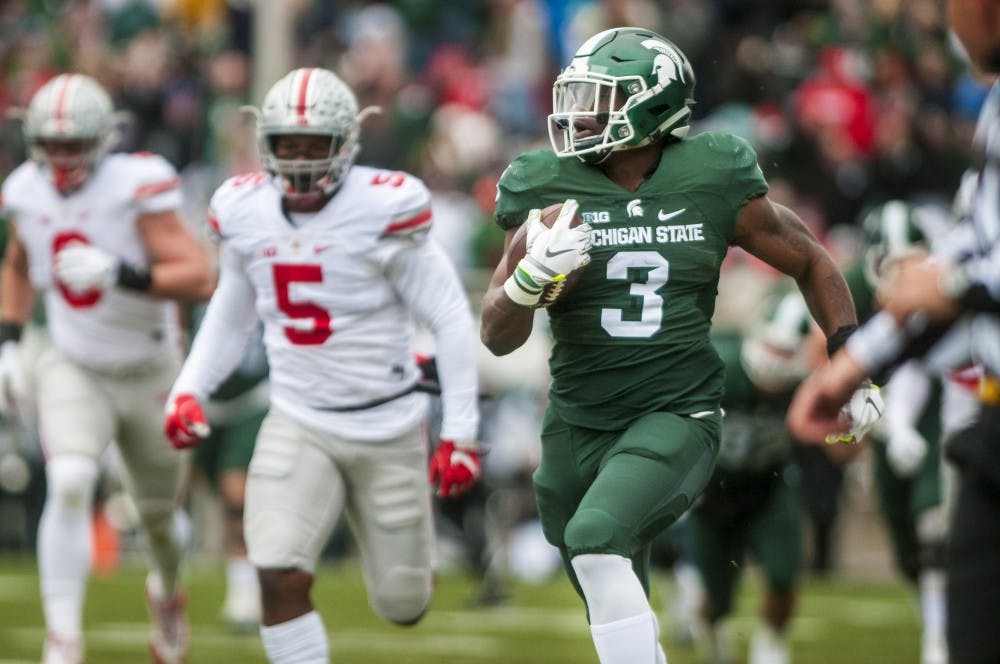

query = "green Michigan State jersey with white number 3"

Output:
[[496, 132, 767, 431]]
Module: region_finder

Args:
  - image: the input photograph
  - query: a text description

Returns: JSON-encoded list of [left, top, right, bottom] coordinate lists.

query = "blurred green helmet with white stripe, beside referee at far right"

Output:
[[862, 200, 930, 288]]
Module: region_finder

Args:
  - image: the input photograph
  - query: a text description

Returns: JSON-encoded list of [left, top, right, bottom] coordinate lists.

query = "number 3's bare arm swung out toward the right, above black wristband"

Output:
[[733, 196, 857, 338]]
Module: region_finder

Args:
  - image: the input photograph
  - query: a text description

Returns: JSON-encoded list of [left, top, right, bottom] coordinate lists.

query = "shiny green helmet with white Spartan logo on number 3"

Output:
[[549, 28, 694, 164]]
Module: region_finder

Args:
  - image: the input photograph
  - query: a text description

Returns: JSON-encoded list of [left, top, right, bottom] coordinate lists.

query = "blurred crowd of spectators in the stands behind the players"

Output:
[[0, 0, 985, 268]]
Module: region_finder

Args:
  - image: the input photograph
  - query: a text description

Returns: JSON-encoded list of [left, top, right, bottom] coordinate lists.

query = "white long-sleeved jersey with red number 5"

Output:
[[173, 166, 478, 440]]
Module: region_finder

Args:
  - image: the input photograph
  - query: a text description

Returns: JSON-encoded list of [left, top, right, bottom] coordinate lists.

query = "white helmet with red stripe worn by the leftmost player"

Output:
[[23, 74, 114, 192]]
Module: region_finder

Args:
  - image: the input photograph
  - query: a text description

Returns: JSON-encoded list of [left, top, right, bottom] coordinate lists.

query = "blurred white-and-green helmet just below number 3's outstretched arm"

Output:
[[740, 291, 812, 393]]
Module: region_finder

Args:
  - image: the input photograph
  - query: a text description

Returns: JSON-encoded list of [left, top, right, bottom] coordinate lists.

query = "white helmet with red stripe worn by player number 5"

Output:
[[257, 68, 359, 202]]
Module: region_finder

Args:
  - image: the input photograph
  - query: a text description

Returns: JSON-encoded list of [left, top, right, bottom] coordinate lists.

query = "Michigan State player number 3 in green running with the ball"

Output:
[[481, 28, 855, 664]]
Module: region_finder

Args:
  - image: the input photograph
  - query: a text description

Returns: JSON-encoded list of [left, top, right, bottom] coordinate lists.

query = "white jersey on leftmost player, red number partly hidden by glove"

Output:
[[3, 153, 181, 370]]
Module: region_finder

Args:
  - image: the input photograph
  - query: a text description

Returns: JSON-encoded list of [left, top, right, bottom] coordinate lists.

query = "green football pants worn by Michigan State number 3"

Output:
[[533, 408, 722, 597]]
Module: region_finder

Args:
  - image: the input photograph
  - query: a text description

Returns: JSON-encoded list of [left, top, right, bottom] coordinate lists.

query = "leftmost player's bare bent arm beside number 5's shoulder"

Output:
[[136, 210, 215, 302]]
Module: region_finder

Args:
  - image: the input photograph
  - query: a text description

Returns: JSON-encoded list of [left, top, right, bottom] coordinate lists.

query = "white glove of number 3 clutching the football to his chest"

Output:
[[503, 198, 591, 307]]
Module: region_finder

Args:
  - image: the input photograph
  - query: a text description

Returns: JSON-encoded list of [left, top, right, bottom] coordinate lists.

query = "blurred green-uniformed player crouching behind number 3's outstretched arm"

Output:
[[688, 284, 812, 664]]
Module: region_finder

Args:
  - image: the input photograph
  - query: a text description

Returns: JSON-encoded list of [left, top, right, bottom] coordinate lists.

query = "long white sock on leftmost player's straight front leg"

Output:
[[38, 455, 97, 638]]
